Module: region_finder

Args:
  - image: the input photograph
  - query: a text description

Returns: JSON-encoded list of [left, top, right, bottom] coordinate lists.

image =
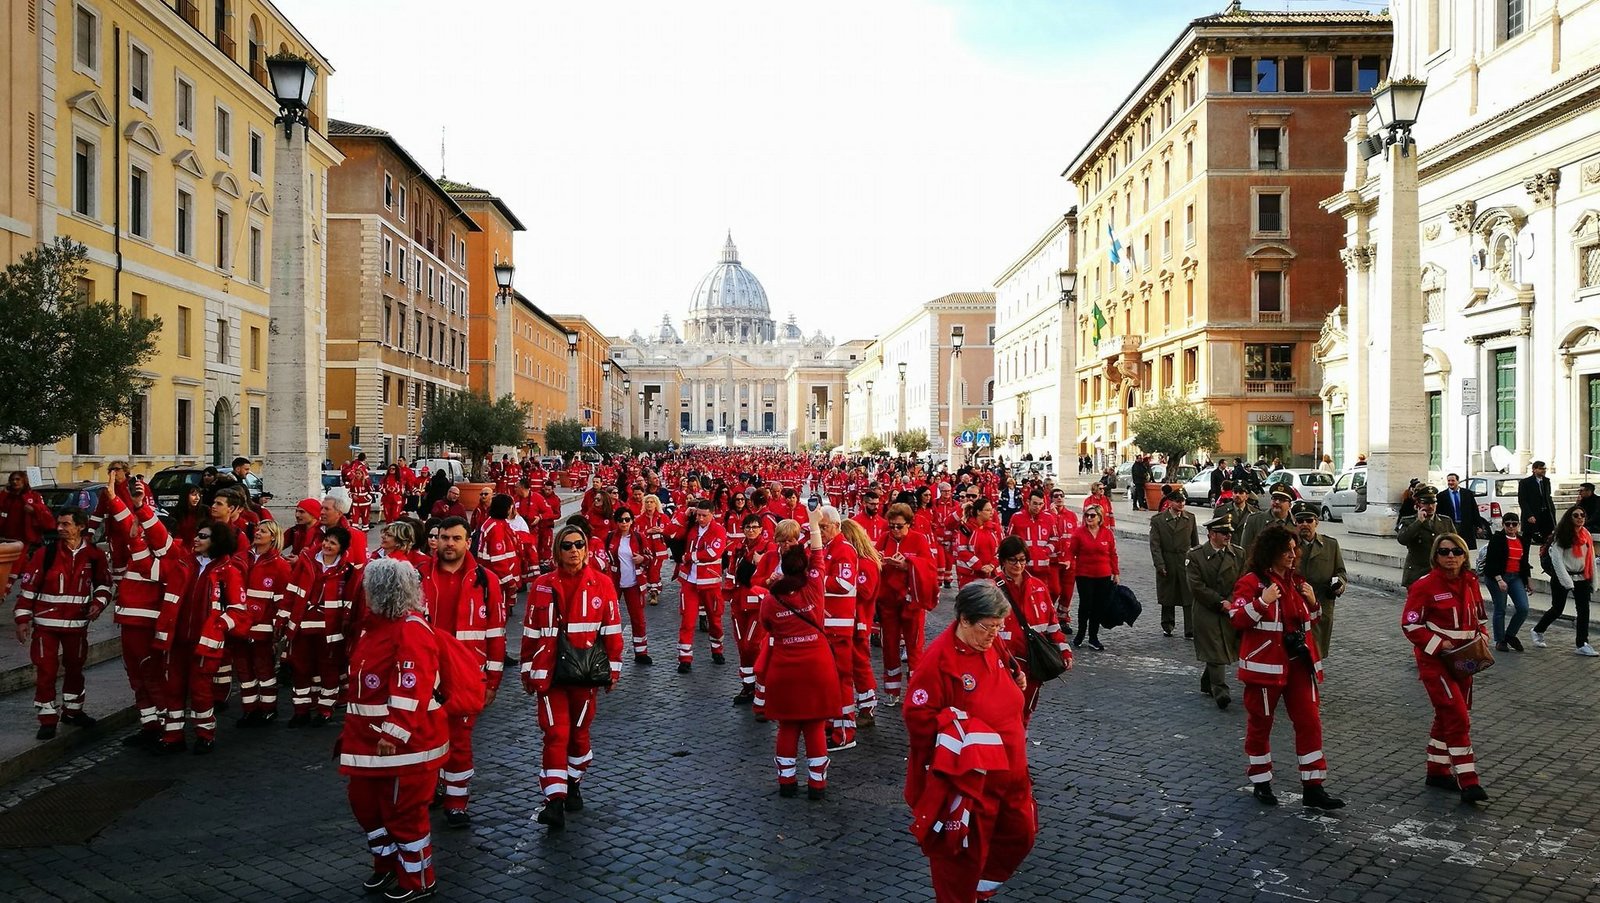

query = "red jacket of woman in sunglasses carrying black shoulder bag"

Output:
[[522, 567, 622, 693]]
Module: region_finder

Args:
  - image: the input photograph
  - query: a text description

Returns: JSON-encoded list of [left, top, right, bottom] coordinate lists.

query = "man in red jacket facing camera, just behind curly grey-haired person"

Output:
[[421, 517, 506, 828]]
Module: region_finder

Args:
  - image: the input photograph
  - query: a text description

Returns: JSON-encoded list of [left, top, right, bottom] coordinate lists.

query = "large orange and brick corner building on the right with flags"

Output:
[[1062, 10, 1392, 466]]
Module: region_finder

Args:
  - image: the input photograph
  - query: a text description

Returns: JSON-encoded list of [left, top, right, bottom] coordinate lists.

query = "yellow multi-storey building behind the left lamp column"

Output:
[[6, 0, 339, 480]]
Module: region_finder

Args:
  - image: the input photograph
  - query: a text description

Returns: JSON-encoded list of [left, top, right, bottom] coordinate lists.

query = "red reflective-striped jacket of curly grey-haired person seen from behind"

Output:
[[339, 613, 450, 778]]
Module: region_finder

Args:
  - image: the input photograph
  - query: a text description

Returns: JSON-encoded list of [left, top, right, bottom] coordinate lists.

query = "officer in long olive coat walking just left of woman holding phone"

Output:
[[1184, 514, 1245, 709]]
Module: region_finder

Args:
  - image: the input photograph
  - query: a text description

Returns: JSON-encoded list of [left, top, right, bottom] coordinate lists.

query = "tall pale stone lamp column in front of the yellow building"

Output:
[[265, 125, 328, 504]]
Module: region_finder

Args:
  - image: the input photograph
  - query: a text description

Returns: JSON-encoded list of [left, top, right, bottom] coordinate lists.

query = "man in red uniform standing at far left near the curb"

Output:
[[16, 509, 110, 740]]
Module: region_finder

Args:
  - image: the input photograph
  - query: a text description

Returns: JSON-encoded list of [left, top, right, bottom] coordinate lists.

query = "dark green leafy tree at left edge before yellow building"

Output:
[[0, 237, 162, 445]]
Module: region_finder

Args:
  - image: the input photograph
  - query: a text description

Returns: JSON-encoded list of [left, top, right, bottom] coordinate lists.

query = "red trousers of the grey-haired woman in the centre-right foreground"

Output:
[[922, 772, 1038, 903]]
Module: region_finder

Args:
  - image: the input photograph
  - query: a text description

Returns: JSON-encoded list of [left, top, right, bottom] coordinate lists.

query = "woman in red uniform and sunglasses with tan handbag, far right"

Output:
[[1400, 533, 1490, 802]]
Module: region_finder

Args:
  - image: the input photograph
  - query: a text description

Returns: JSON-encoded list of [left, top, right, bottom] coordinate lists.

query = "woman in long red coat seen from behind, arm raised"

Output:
[[762, 511, 843, 799]]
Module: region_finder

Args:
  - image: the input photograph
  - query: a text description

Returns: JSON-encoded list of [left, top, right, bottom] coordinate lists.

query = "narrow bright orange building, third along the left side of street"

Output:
[[438, 179, 525, 397]]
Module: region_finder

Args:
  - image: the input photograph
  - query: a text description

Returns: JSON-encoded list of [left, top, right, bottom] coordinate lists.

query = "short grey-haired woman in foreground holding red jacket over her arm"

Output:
[[906, 580, 1038, 903]]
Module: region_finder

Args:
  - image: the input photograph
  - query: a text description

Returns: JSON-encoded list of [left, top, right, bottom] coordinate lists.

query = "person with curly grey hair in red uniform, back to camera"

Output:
[[339, 559, 450, 900]]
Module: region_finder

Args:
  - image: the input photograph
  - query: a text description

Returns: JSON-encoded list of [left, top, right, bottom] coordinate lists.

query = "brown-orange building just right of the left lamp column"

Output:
[[326, 120, 473, 468]]
